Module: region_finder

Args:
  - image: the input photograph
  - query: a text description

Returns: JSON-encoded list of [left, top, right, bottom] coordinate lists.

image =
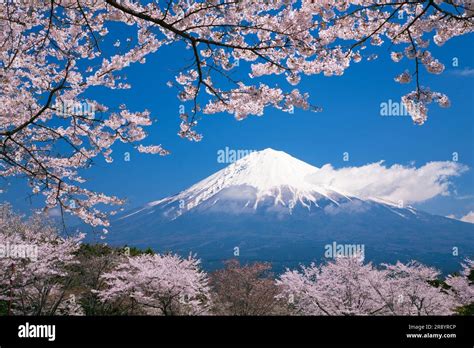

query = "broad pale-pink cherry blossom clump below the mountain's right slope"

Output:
[[277, 256, 456, 315]]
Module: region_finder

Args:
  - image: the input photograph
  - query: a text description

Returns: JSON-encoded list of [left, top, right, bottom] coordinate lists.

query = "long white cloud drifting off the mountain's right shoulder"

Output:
[[308, 161, 468, 204]]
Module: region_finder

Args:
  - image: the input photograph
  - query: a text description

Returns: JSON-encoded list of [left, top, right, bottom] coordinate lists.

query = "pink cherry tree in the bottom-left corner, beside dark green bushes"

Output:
[[0, 205, 84, 315]]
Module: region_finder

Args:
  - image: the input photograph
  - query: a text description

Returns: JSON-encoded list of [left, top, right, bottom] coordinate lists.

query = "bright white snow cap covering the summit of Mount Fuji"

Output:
[[148, 148, 347, 209]]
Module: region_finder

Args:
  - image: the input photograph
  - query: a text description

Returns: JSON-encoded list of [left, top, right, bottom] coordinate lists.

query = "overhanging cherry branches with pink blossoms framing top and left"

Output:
[[0, 0, 473, 225]]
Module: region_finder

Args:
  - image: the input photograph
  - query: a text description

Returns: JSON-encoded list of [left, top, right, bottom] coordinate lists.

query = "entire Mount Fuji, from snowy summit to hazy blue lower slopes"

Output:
[[97, 149, 474, 272]]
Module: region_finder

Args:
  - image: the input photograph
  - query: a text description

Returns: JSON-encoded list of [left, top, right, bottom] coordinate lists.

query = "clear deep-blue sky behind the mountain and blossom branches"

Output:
[[4, 30, 474, 220]]
